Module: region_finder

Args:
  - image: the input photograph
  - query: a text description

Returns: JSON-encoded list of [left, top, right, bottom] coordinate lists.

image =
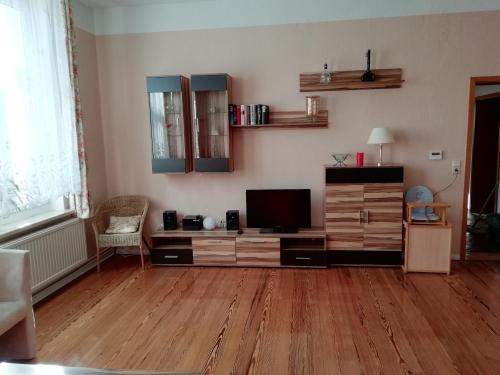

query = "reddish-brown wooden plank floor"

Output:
[[35, 257, 500, 375]]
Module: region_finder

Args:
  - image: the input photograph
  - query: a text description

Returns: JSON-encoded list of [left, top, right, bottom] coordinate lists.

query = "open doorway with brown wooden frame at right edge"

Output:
[[460, 77, 500, 260]]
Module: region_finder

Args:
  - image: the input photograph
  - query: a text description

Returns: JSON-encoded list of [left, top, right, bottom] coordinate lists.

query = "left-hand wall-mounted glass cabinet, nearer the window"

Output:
[[146, 76, 193, 173]]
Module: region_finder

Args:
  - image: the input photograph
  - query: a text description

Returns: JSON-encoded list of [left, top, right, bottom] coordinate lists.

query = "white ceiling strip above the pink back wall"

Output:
[[75, 0, 500, 35]]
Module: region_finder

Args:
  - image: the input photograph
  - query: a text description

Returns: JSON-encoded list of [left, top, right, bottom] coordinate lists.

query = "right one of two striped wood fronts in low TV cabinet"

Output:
[[236, 237, 280, 267]]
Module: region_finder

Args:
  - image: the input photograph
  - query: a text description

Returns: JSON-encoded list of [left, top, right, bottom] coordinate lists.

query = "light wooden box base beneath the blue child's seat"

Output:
[[402, 221, 451, 275]]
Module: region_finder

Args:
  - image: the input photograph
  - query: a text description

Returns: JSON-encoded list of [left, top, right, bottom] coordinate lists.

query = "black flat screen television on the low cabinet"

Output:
[[246, 189, 311, 233]]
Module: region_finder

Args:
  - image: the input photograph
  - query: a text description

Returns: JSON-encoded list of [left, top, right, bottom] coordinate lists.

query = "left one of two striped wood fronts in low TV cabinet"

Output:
[[193, 237, 236, 266]]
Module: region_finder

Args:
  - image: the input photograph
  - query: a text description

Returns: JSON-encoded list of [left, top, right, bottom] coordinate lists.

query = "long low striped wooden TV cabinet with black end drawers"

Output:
[[150, 228, 327, 267]]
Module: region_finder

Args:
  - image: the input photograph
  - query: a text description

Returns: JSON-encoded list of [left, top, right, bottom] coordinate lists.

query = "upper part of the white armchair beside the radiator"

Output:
[[0, 249, 31, 306]]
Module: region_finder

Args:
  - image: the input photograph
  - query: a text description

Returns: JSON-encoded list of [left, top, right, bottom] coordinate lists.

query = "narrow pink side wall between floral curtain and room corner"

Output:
[[76, 29, 108, 257]]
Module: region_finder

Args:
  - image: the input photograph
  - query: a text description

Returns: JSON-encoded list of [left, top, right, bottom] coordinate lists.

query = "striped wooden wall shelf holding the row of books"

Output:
[[231, 110, 328, 129]]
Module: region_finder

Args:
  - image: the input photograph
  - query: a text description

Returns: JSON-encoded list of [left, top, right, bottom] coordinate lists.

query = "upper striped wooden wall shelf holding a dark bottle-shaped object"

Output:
[[299, 69, 404, 92]]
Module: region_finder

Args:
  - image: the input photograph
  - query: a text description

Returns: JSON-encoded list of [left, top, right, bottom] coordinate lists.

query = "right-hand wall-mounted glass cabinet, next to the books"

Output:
[[191, 74, 233, 172]]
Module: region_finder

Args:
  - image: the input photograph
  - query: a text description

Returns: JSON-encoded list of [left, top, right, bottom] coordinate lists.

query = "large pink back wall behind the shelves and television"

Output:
[[88, 12, 500, 253]]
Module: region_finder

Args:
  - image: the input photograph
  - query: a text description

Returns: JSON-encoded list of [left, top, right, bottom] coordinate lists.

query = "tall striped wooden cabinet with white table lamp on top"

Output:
[[325, 166, 404, 265]]
